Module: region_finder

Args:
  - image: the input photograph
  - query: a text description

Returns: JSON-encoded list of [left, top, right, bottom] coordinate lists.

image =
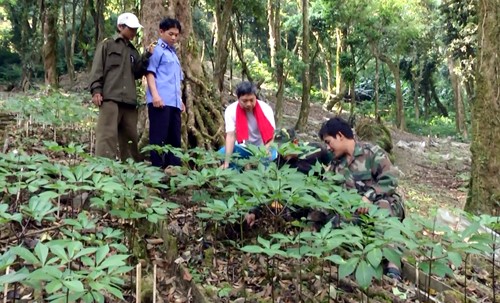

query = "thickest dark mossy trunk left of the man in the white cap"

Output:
[[43, 1, 59, 87]]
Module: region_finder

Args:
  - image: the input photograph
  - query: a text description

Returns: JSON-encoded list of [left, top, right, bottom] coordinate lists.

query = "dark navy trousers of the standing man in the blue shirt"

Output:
[[148, 103, 181, 168]]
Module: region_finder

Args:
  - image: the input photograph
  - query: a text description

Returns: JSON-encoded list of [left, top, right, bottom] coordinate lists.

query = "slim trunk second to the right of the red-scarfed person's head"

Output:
[[295, 0, 311, 131]]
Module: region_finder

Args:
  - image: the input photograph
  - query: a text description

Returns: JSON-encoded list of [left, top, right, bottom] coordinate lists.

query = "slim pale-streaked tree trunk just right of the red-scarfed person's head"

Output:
[[267, 0, 285, 127]]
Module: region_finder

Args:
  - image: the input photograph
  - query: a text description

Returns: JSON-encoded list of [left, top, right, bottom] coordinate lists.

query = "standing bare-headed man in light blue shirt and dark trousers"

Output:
[[146, 18, 185, 168]]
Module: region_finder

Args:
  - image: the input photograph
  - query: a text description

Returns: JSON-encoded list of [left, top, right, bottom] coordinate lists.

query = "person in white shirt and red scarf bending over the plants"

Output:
[[219, 81, 277, 168]]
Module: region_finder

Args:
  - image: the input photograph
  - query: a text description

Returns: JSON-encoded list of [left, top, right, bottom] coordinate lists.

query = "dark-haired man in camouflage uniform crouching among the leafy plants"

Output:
[[318, 118, 405, 280]]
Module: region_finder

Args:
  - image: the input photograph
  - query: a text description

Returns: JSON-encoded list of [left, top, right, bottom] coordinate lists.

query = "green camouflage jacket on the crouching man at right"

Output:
[[330, 141, 397, 201]]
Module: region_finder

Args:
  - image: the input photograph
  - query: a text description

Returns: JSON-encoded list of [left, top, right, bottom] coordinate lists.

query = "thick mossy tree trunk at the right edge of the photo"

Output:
[[465, 0, 500, 216]]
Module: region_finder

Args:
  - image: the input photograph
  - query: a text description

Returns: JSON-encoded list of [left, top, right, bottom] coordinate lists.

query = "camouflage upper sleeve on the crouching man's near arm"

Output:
[[364, 147, 398, 201]]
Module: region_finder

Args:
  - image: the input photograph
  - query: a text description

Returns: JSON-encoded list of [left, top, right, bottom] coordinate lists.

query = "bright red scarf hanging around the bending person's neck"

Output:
[[236, 100, 274, 144]]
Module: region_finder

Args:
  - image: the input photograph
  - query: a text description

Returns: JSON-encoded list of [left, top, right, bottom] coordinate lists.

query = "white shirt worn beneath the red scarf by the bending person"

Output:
[[224, 100, 276, 146]]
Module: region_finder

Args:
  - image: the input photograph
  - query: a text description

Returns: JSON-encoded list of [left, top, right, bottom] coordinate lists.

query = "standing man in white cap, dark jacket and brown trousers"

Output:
[[90, 13, 150, 161]]
